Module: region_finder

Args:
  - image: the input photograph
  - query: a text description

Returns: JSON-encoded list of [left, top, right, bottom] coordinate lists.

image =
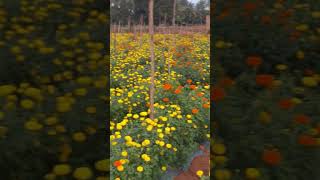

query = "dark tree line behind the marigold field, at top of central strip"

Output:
[[110, 0, 210, 26]]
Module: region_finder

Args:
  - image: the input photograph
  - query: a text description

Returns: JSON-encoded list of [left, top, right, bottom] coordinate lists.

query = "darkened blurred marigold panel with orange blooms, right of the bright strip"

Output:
[[211, 0, 320, 180]]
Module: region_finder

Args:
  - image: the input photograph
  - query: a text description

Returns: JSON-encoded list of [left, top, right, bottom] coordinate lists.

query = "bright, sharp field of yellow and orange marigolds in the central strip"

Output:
[[110, 33, 210, 180]]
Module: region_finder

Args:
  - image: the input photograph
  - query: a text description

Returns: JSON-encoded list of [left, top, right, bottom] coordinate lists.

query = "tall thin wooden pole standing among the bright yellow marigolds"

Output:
[[149, 0, 155, 120]]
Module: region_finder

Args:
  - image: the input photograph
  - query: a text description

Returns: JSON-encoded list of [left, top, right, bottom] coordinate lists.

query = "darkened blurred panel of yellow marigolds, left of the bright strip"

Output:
[[0, 0, 109, 180]]
